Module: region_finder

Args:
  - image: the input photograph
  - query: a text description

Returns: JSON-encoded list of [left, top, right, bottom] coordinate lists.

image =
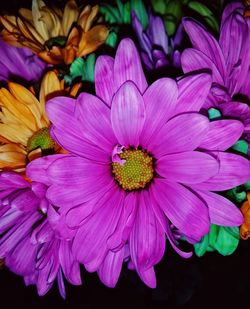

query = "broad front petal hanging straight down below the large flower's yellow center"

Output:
[[129, 191, 165, 274]]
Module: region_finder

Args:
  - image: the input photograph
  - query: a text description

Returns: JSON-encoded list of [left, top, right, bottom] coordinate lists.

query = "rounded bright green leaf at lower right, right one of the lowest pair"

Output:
[[214, 226, 239, 256]]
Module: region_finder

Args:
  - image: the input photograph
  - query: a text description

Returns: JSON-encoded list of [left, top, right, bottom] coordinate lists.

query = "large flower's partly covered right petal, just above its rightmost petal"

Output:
[[199, 120, 244, 151]]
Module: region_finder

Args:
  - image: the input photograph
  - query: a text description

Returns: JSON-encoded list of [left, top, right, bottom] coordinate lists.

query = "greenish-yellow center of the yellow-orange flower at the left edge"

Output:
[[26, 128, 55, 153]]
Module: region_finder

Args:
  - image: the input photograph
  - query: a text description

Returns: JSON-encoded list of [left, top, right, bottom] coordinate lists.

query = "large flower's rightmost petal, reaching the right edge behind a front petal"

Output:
[[192, 152, 250, 191]]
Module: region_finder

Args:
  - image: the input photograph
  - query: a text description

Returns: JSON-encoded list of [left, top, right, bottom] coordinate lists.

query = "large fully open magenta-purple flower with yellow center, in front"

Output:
[[27, 39, 250, 287]]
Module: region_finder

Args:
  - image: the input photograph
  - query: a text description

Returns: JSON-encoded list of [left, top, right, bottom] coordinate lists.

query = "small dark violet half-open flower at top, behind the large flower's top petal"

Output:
[[132, 11, 182, 70]]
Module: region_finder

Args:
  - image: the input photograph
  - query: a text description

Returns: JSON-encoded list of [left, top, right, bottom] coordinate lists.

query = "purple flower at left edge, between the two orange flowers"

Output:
[[0, 40, 47, 81]]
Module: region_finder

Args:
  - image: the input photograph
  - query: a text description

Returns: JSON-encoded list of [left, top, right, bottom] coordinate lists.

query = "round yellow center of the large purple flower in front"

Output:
[[112, 149, 154, 191]]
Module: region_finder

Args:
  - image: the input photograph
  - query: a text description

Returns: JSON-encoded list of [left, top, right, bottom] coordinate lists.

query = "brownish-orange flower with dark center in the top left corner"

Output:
[[0, 0, 108, 64]]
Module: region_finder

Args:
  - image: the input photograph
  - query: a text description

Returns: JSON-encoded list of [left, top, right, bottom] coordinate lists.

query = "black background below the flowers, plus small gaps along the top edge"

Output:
[[0, 0, 250, 309]]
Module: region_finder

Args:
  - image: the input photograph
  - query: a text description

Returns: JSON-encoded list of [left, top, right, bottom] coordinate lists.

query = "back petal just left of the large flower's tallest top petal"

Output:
[[95, 56, 115, 106]]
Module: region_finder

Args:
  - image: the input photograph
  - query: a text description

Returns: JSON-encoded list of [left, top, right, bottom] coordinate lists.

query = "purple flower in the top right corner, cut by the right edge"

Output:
[[181, 2, 250, 134]]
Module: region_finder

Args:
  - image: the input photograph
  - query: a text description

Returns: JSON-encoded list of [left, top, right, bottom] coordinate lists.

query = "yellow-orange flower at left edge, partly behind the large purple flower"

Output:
[[0, 71, 81, 172]]
